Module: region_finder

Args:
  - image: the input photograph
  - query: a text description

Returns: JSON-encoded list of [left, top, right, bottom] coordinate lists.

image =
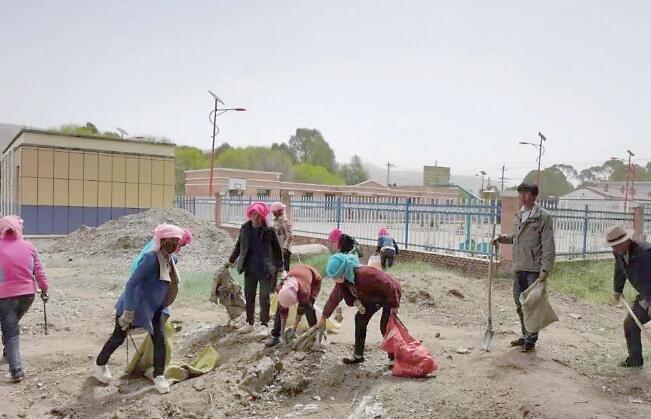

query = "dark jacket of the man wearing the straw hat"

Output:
[[613, 240, 651, 299]]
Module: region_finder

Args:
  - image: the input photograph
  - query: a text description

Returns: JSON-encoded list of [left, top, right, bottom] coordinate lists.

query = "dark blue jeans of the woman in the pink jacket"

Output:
[[0, 294, 34, 375]]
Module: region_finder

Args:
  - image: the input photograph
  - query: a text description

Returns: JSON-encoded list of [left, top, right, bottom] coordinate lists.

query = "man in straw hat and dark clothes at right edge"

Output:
[[606, 226, 651, 368]]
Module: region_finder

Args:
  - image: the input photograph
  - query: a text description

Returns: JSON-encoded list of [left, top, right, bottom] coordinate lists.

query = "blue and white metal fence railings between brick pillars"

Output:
[[176, 197, 640, 259]]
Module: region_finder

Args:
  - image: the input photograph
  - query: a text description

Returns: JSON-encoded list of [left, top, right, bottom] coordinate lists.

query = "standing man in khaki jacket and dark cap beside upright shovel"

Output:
[[495, 183, 556, 352]]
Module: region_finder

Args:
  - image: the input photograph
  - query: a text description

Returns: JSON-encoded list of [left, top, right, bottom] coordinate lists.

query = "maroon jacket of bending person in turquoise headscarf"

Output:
[[323, 266, 401, 318]]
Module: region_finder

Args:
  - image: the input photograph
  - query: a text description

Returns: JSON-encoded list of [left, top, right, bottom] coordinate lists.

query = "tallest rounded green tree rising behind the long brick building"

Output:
[[287, 128, 337, 172]]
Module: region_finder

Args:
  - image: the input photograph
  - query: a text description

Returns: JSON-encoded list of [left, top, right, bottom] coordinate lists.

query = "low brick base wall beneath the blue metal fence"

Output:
[[220, 226, 500, 277]]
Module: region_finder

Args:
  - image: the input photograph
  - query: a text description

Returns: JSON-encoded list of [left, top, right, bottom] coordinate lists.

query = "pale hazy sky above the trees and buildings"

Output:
[[0, 0, 651, 185]]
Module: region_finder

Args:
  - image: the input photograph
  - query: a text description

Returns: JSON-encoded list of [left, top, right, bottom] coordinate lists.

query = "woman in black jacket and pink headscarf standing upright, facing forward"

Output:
[[225, 202, 283, 337]]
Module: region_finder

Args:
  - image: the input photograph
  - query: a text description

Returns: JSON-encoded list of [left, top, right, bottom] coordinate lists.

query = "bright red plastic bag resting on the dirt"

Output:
[[382, 314, 438, 378]]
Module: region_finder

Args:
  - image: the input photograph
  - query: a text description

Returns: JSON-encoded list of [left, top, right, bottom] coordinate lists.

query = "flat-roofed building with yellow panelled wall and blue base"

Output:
[[2, 132, 175, 234]]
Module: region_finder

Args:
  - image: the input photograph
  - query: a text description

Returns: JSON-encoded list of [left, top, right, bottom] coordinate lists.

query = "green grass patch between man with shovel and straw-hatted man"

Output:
[[549, 260, 636, 304]]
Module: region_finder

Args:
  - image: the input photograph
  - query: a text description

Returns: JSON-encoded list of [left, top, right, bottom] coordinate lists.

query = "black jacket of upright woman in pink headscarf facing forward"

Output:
[[228, 220, 283, 276]]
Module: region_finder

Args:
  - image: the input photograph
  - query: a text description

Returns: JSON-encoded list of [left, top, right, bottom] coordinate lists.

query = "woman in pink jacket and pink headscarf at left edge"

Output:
[[0, 215, 48, 383]]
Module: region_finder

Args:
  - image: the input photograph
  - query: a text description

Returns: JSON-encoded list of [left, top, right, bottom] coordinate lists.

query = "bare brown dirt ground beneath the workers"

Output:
[[0, 241, 651, 418]]
